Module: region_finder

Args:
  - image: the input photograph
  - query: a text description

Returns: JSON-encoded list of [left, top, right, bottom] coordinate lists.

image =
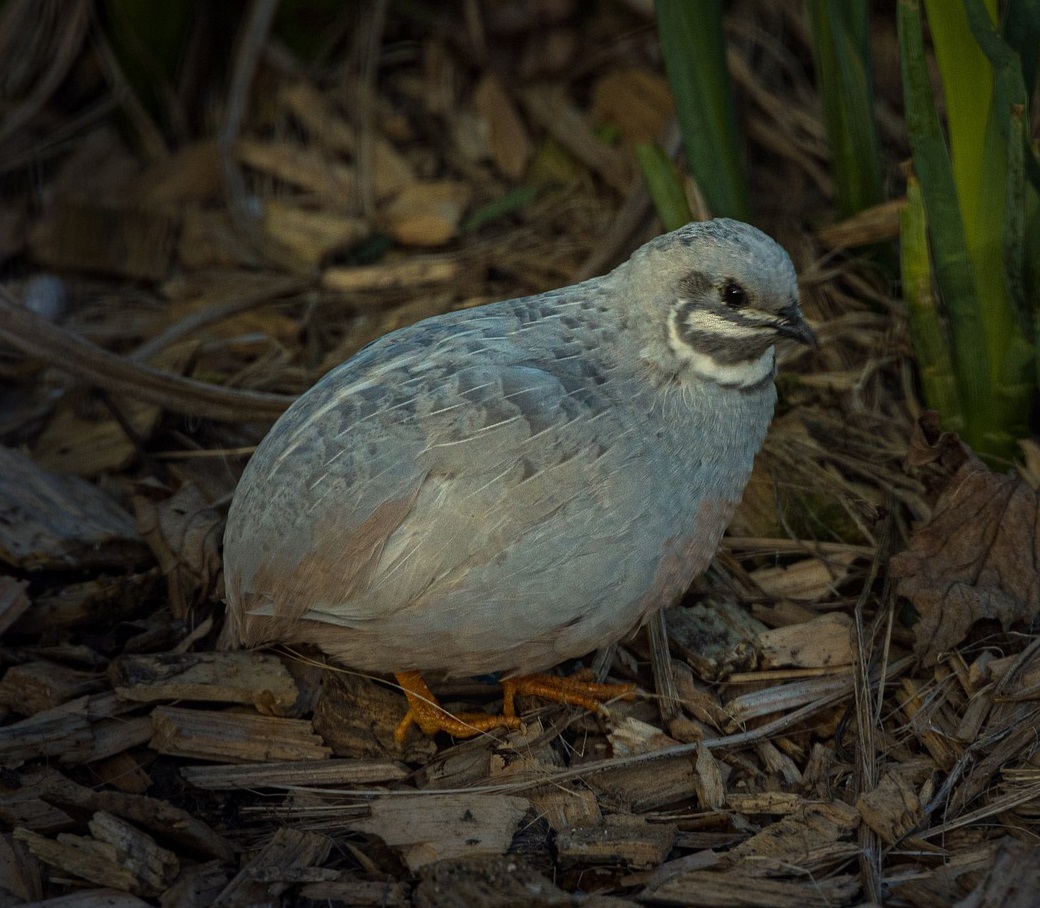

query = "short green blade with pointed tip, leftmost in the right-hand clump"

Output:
[[900, 174, 964, 432]]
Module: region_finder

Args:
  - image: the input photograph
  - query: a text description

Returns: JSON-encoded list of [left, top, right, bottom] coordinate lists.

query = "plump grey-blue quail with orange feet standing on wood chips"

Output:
[[223, 218, 815, 742]]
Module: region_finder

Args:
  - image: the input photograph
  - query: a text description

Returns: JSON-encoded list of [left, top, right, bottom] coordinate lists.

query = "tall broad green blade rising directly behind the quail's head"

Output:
[[656, 0, 750, 220]]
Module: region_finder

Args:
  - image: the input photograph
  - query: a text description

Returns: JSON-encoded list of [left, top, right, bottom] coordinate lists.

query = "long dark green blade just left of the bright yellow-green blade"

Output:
[[896, 0, 992, 450]]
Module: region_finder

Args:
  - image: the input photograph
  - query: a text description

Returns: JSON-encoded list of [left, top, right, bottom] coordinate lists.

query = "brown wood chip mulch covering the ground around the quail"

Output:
[[0, 0, 1040, 908]]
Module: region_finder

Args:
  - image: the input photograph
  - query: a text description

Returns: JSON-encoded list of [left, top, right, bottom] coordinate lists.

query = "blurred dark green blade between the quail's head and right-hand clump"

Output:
[[806, 0, 882, 217]]
